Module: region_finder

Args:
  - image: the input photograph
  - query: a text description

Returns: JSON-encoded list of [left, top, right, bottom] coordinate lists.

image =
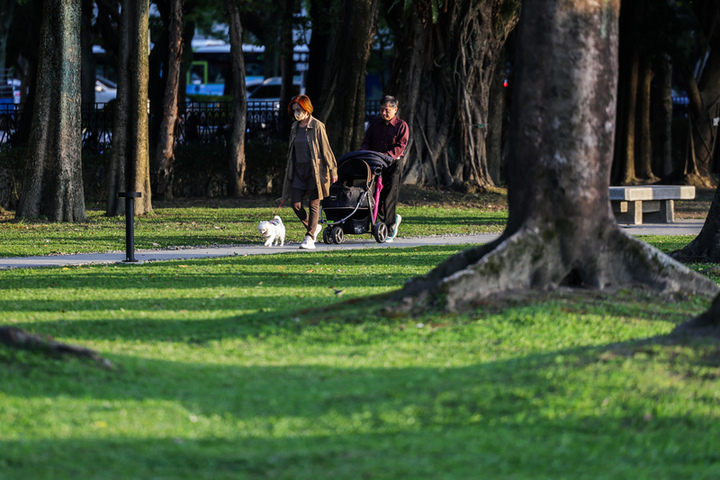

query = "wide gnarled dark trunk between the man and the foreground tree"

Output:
[[385, 0, 519, 186]]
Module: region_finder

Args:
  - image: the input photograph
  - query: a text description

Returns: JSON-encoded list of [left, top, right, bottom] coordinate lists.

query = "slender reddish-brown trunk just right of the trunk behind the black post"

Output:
[[155, 0, 183, 198]]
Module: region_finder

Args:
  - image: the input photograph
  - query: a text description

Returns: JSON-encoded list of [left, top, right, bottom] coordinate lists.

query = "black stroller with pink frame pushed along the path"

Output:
[[320, 150, 392, 244]]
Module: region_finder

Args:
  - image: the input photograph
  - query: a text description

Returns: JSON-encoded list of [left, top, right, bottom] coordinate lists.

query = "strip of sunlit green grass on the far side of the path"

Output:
[[0, 201, 507, 257]]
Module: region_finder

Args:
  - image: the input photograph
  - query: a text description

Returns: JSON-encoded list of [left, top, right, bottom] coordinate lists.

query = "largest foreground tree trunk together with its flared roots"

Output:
[[398, 0, 718, 309]]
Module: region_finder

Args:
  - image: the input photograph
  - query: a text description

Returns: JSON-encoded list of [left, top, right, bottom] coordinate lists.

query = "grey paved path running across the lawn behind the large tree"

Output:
[[0, 220, 704, 269]]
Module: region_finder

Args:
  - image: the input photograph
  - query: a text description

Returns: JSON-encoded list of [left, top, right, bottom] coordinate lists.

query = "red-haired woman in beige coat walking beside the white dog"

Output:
[[283, 95, 338, 250]]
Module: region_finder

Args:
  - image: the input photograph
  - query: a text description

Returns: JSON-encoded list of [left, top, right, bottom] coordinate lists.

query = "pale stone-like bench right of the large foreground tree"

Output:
[[610, 185, 695, 225]]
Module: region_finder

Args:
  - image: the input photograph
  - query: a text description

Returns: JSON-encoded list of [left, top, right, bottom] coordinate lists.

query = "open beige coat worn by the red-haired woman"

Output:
[[283, 117, 337, 200]]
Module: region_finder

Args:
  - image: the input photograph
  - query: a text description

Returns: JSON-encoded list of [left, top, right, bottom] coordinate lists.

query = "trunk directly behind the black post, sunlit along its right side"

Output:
[[107, 0, 152, 216]]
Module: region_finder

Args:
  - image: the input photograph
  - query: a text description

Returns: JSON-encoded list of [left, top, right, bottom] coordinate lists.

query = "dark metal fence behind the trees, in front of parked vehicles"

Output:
[[0, 100, 380, 152]]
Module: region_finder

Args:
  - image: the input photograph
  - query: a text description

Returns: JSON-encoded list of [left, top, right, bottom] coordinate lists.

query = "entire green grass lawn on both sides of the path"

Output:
[[0, 196, 720, 480]]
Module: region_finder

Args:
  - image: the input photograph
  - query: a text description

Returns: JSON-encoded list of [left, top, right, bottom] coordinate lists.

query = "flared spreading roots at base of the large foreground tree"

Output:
[[396, 224, 718, 311]]
